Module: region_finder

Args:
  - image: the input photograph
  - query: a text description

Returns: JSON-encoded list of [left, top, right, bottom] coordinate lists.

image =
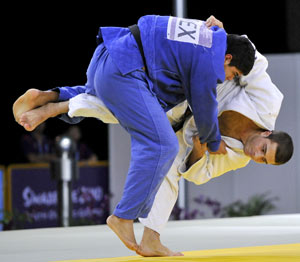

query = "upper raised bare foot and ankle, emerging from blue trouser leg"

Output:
[[13, 89, 59, 123]]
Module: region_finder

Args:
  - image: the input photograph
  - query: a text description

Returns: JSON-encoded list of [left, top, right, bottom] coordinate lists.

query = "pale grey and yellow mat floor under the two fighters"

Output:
[[0, 214, 300, 262]]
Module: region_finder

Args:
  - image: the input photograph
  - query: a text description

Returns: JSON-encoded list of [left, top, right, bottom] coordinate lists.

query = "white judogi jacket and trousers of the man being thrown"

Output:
[[68, 52, 283, 233]]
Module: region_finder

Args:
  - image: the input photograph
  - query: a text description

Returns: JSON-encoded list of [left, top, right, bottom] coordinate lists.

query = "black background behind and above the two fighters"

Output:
[[0, 0, 300, 165]]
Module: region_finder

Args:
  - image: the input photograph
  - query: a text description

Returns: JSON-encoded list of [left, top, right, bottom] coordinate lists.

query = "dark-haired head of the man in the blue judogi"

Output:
[[224, 34, 255, 80]]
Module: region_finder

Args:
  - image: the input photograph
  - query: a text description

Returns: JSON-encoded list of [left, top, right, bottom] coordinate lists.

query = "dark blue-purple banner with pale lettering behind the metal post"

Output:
[[10, 164, 109, 229]]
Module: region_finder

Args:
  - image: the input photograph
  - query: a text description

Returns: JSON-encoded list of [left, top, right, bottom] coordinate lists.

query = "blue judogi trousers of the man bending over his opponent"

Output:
[[60, 44, 179, 219]]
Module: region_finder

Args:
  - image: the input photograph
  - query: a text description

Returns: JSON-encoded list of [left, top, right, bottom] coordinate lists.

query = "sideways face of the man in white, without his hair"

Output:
[[244, 131, 277, 165]]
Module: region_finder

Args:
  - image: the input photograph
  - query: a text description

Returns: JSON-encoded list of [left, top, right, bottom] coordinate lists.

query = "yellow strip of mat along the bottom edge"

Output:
[[55, 243, 300, 262]]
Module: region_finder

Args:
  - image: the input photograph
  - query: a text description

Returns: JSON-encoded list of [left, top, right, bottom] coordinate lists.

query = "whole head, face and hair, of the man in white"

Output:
[[244, 131, 294, 165]]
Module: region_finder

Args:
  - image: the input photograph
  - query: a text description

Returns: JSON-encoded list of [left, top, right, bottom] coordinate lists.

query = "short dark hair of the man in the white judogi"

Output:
[[268, 131, 294, 165]]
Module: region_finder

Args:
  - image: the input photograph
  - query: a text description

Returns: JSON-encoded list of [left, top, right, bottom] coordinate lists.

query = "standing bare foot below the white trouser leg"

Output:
[[136, 227, 183, 257]]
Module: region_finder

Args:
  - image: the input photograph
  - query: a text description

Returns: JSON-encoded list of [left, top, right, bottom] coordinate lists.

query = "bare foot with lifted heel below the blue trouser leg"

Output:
[[106, 215, 138, 251]]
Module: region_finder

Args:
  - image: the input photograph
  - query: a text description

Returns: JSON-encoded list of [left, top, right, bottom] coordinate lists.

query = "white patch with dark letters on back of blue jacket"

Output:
[[167, 16, 213, 48]]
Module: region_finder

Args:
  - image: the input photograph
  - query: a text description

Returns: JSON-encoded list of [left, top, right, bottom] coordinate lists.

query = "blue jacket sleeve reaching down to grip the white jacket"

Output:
[[187, 27, 226, 151]]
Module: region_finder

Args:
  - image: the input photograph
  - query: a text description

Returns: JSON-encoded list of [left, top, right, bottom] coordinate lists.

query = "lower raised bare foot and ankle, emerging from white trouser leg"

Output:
[[19, 101, 69, 131]]
